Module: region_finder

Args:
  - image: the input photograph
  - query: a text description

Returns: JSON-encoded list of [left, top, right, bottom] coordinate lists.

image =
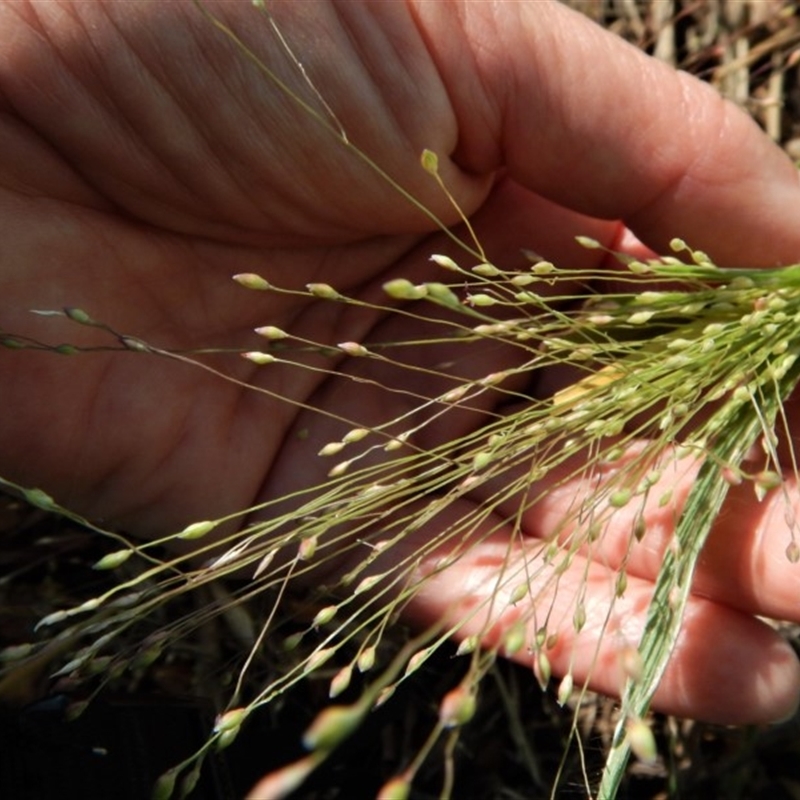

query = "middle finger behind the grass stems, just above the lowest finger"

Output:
[[473, 441, 800, 620]]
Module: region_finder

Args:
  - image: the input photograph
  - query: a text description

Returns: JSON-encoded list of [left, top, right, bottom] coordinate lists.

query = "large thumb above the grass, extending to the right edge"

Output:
[[417, 2, 800, 265]]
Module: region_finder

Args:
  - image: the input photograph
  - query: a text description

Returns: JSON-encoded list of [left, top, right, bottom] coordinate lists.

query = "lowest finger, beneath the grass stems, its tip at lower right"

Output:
[[394, 508, 800, 724]]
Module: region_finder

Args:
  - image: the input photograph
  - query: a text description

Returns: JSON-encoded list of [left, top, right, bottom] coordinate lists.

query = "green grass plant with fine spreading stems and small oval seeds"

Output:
[[0, 1, 800, 798]]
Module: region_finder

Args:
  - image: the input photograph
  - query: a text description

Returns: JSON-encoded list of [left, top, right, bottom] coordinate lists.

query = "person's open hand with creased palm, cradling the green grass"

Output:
[[0, 0, 800, 723]]
